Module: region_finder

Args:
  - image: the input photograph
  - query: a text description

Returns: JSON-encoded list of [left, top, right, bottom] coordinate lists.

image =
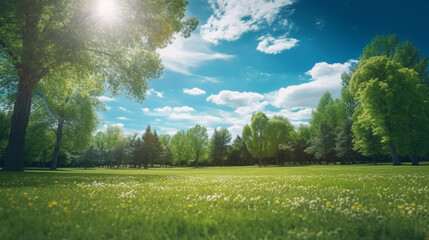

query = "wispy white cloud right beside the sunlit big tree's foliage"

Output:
[[158, 35, 234, 76]]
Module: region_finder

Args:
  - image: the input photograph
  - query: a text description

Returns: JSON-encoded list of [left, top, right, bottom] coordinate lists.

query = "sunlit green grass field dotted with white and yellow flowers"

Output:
[[0, 165, 429, 240]]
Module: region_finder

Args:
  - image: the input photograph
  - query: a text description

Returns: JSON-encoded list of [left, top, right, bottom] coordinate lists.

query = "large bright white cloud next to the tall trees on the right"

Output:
[[266, 60, 357, 109]]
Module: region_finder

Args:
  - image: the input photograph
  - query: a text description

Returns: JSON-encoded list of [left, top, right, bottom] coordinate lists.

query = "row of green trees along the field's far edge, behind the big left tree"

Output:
[[0, 35, 429, 169]]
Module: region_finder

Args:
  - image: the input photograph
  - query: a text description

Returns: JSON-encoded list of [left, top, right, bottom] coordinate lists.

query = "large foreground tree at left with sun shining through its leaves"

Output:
[[0, 0, 198, 171]]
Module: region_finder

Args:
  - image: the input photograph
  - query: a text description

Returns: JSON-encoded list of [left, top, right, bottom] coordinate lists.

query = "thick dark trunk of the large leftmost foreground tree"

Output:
[[3, 80, 34, 171]]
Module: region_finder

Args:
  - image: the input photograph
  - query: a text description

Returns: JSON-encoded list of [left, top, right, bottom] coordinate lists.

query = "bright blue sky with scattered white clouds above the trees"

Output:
[[98, 0, 429, 138]]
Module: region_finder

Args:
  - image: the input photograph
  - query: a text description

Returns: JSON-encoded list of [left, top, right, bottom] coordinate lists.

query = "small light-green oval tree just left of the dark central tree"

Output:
[[186, 124, 209, 168]]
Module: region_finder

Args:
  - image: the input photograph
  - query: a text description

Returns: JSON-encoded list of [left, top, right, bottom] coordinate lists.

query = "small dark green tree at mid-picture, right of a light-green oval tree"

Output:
[[210, 128, 231, 166]]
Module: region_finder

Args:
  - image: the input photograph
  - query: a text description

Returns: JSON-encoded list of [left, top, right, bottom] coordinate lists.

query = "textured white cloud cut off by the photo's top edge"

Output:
[[200, 0, 293, 44]]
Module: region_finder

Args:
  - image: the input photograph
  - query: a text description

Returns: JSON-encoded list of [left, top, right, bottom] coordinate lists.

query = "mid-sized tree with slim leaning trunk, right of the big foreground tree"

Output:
[[33, 64, 103, 170]]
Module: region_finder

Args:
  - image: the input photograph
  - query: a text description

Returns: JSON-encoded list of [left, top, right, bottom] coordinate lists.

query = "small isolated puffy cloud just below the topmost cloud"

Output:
[[256, 36, 298, 54]]
